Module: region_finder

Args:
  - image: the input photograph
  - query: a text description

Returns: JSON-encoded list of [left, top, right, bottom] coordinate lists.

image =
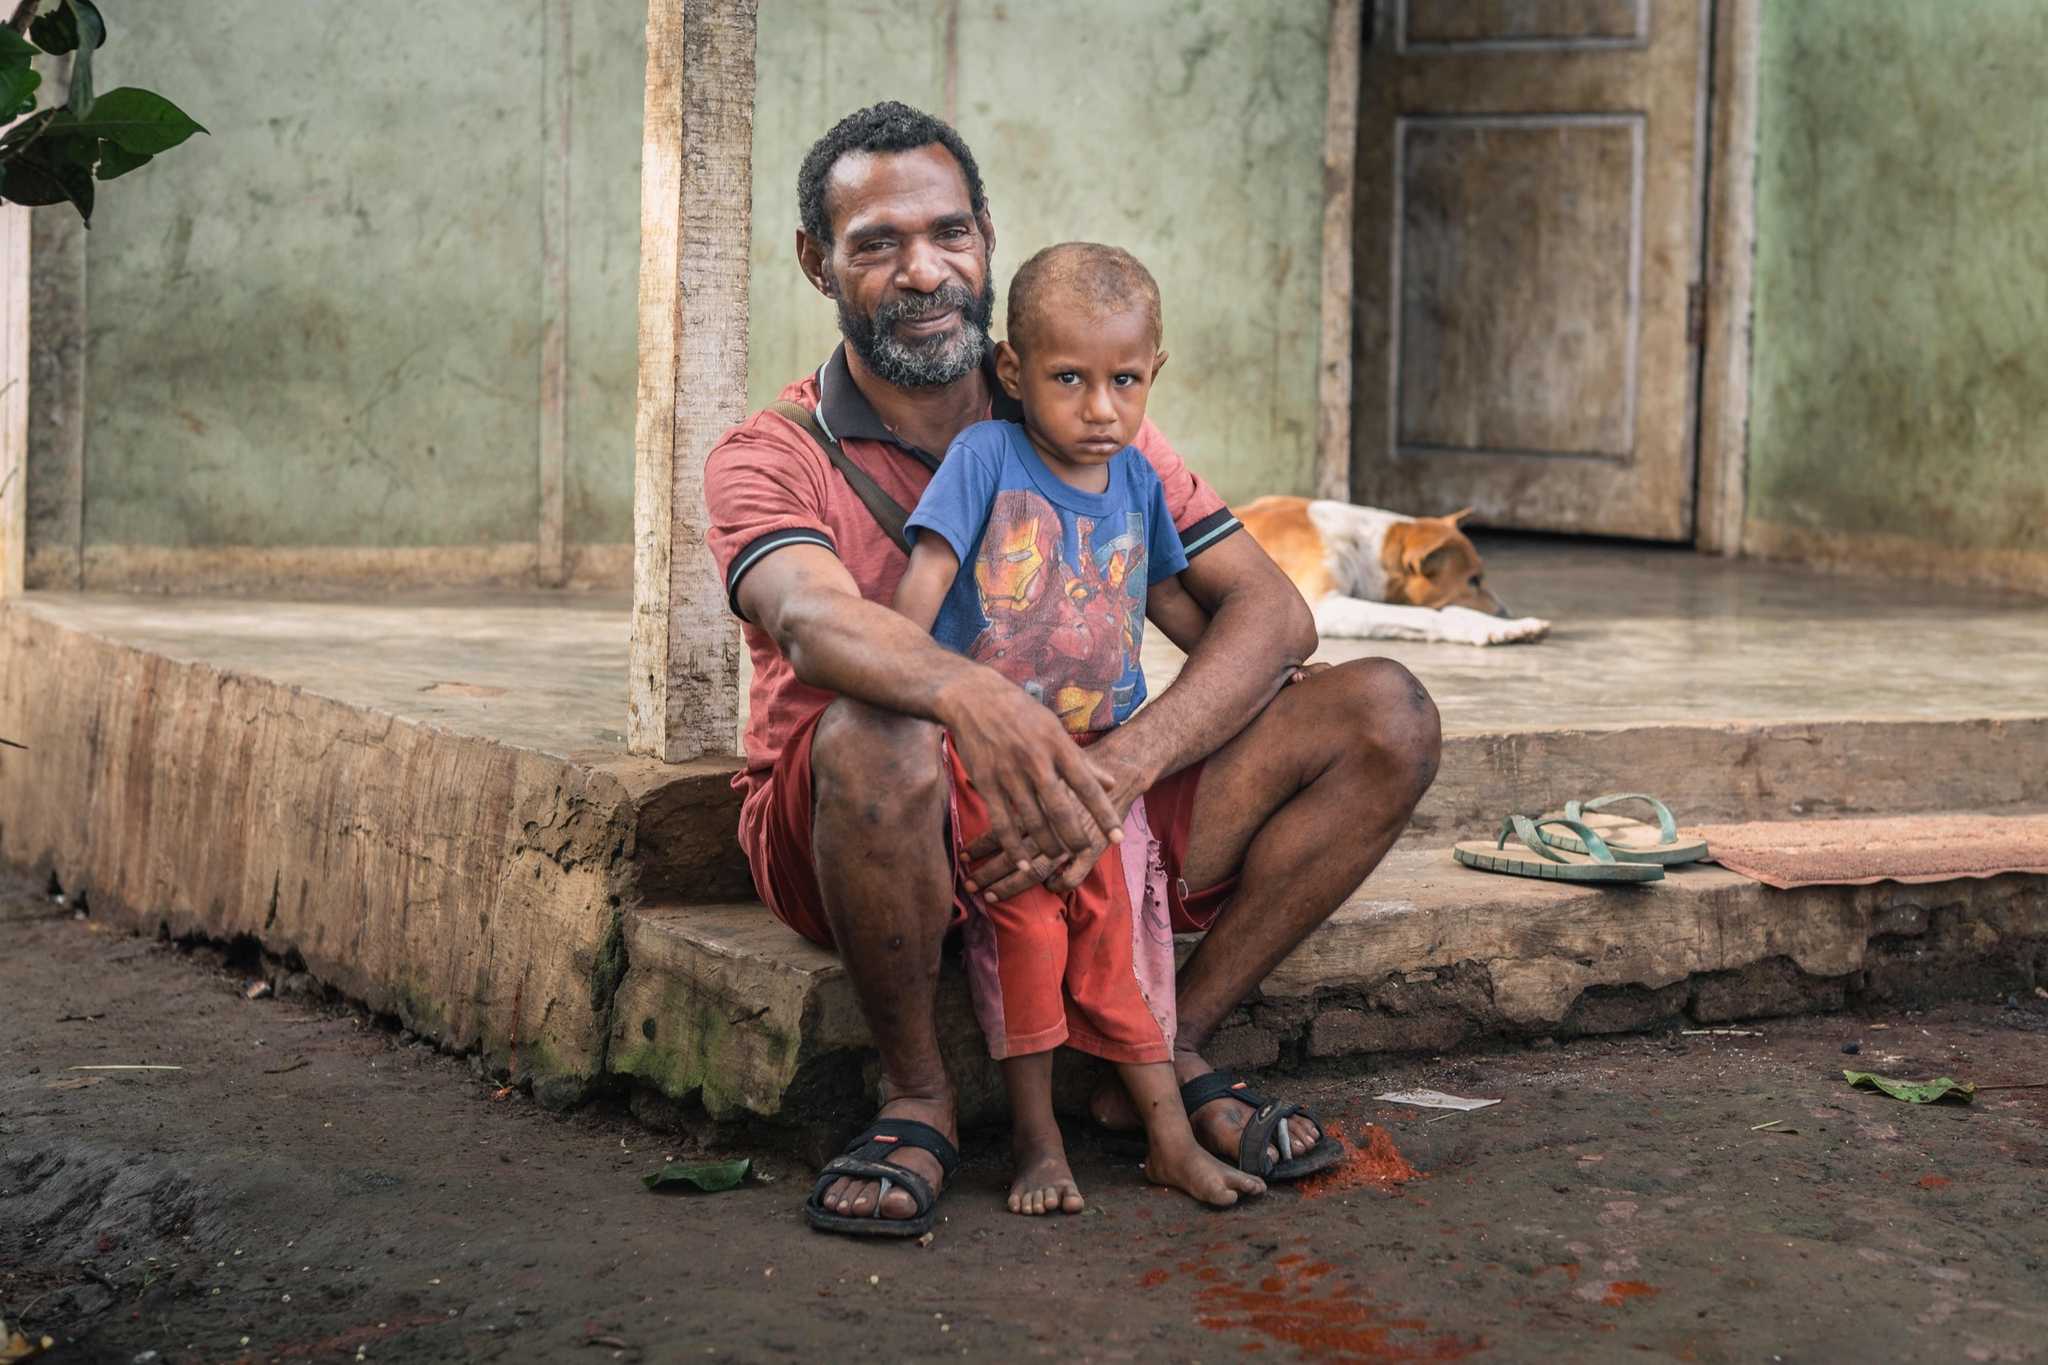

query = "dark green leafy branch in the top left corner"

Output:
[[0, 0, 207, 225]]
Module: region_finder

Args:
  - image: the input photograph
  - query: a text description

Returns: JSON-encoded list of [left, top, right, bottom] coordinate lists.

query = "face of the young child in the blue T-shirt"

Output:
[[995, 309, 1165, 474]]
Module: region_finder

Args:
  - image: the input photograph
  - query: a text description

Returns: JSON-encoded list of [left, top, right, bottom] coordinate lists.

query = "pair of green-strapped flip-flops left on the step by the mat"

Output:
[[1450, 792, 1706, 882]]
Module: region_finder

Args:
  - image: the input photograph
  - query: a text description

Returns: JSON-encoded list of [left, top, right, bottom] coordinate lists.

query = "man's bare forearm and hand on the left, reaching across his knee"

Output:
[[739, 536, 1124, 880]]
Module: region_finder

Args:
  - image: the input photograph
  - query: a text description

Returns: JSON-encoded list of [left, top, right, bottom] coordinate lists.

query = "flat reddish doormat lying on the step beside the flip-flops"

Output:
[[1686, 814, 2048, 890]]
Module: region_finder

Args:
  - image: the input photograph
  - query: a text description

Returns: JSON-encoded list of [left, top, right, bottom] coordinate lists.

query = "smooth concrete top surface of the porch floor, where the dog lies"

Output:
[[27, 538, 2048, 757]]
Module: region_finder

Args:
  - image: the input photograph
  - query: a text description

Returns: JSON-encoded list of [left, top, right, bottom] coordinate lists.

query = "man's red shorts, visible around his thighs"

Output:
[[750, 708, 1237, 948]]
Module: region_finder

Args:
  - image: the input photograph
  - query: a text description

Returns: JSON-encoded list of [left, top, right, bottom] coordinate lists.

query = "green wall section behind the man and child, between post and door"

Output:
[[752, 0, 1329, 497]]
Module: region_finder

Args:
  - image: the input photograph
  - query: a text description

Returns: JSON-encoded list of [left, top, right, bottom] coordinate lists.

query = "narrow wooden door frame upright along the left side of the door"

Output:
[[1315, 0, 1364, 501]]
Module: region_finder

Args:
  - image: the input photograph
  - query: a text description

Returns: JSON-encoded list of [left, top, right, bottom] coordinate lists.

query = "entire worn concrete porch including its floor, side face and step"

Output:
[[12, 538, 2048, 1117]]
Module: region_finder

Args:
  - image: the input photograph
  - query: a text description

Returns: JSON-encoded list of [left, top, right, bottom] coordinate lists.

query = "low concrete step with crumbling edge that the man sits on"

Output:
[[610, 847, 2048, 1124]]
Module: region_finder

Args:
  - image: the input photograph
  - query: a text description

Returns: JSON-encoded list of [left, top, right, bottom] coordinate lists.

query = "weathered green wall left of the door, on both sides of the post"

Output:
[[44, 0, 1327, 573]]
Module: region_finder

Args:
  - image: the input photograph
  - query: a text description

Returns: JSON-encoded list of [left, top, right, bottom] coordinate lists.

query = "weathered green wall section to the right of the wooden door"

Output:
[[1745, 0, 2048, 577]]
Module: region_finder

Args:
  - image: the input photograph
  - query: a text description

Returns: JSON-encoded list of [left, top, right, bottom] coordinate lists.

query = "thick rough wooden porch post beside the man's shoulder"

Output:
[[627, 0, 758, 763]]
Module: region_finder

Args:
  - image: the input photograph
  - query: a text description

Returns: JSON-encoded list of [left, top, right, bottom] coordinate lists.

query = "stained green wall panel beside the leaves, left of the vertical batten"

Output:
[[84, 0, 541, 548]]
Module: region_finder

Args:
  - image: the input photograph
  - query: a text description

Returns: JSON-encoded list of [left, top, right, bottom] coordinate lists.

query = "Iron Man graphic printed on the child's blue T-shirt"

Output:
[[971, 489, 1145, 735]]
